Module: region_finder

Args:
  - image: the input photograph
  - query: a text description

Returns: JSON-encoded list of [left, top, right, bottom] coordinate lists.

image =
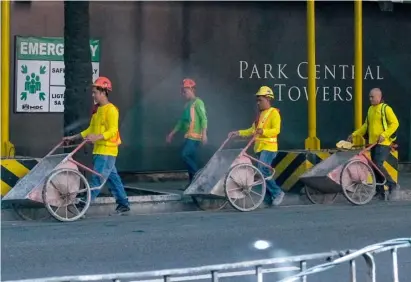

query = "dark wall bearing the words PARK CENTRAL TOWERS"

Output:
[[11, 2, 411, 171]]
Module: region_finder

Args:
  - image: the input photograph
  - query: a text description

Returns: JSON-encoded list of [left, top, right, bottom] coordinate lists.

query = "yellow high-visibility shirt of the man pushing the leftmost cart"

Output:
[[80, 103, 121, 157]]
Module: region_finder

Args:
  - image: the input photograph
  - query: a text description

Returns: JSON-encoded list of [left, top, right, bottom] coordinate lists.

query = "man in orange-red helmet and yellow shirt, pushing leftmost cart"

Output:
[[64, 77, 130, 214]]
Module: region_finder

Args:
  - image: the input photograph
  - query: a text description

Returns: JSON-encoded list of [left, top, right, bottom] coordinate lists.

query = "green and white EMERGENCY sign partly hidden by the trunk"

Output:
[[15, 36, 100, 113]]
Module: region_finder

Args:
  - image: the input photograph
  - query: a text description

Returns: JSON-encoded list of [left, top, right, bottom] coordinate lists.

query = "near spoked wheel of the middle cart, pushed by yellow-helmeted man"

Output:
[[224, 163, 266, 212]]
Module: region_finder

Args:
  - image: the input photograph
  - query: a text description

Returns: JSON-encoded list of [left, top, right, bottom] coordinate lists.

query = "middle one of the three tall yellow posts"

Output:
[[305, 0, 321, 150]]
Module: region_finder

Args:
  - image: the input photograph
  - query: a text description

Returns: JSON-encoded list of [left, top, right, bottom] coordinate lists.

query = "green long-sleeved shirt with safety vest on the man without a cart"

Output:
[[174, 98, 207, 140]]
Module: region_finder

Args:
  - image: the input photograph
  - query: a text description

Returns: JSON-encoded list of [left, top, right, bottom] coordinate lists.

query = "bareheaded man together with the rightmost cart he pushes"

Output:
[[300, 88, 399, 205]]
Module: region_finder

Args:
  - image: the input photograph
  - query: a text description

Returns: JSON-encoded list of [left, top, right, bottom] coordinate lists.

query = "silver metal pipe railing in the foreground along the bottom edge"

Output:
[[5, 238, 411, 282]]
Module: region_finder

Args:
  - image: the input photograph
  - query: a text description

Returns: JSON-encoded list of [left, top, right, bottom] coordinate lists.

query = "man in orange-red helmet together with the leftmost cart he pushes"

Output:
[[2, 77, 130, 222]]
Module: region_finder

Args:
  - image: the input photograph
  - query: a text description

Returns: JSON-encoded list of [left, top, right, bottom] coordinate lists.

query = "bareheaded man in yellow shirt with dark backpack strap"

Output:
[[347, 88, 400, 197]]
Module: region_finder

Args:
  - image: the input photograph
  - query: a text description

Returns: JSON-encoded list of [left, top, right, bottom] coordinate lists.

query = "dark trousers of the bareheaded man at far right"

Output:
[[371, 145, 397, 193]]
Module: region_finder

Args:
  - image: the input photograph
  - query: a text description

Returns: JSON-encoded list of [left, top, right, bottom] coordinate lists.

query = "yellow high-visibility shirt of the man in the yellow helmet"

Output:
[[239, 108, 281, 153]]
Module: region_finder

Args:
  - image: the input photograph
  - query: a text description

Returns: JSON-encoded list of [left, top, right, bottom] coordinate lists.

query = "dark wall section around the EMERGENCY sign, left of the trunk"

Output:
[[10, 1, 64, 157]]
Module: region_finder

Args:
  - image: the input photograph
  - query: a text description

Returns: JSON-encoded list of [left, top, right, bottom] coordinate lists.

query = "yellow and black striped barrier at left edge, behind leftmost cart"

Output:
[[1, 158, 38, 197]]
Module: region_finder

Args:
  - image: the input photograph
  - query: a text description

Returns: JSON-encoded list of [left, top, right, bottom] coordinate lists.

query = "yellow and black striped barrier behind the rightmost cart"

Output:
[[272, 150, 398, 193]]
